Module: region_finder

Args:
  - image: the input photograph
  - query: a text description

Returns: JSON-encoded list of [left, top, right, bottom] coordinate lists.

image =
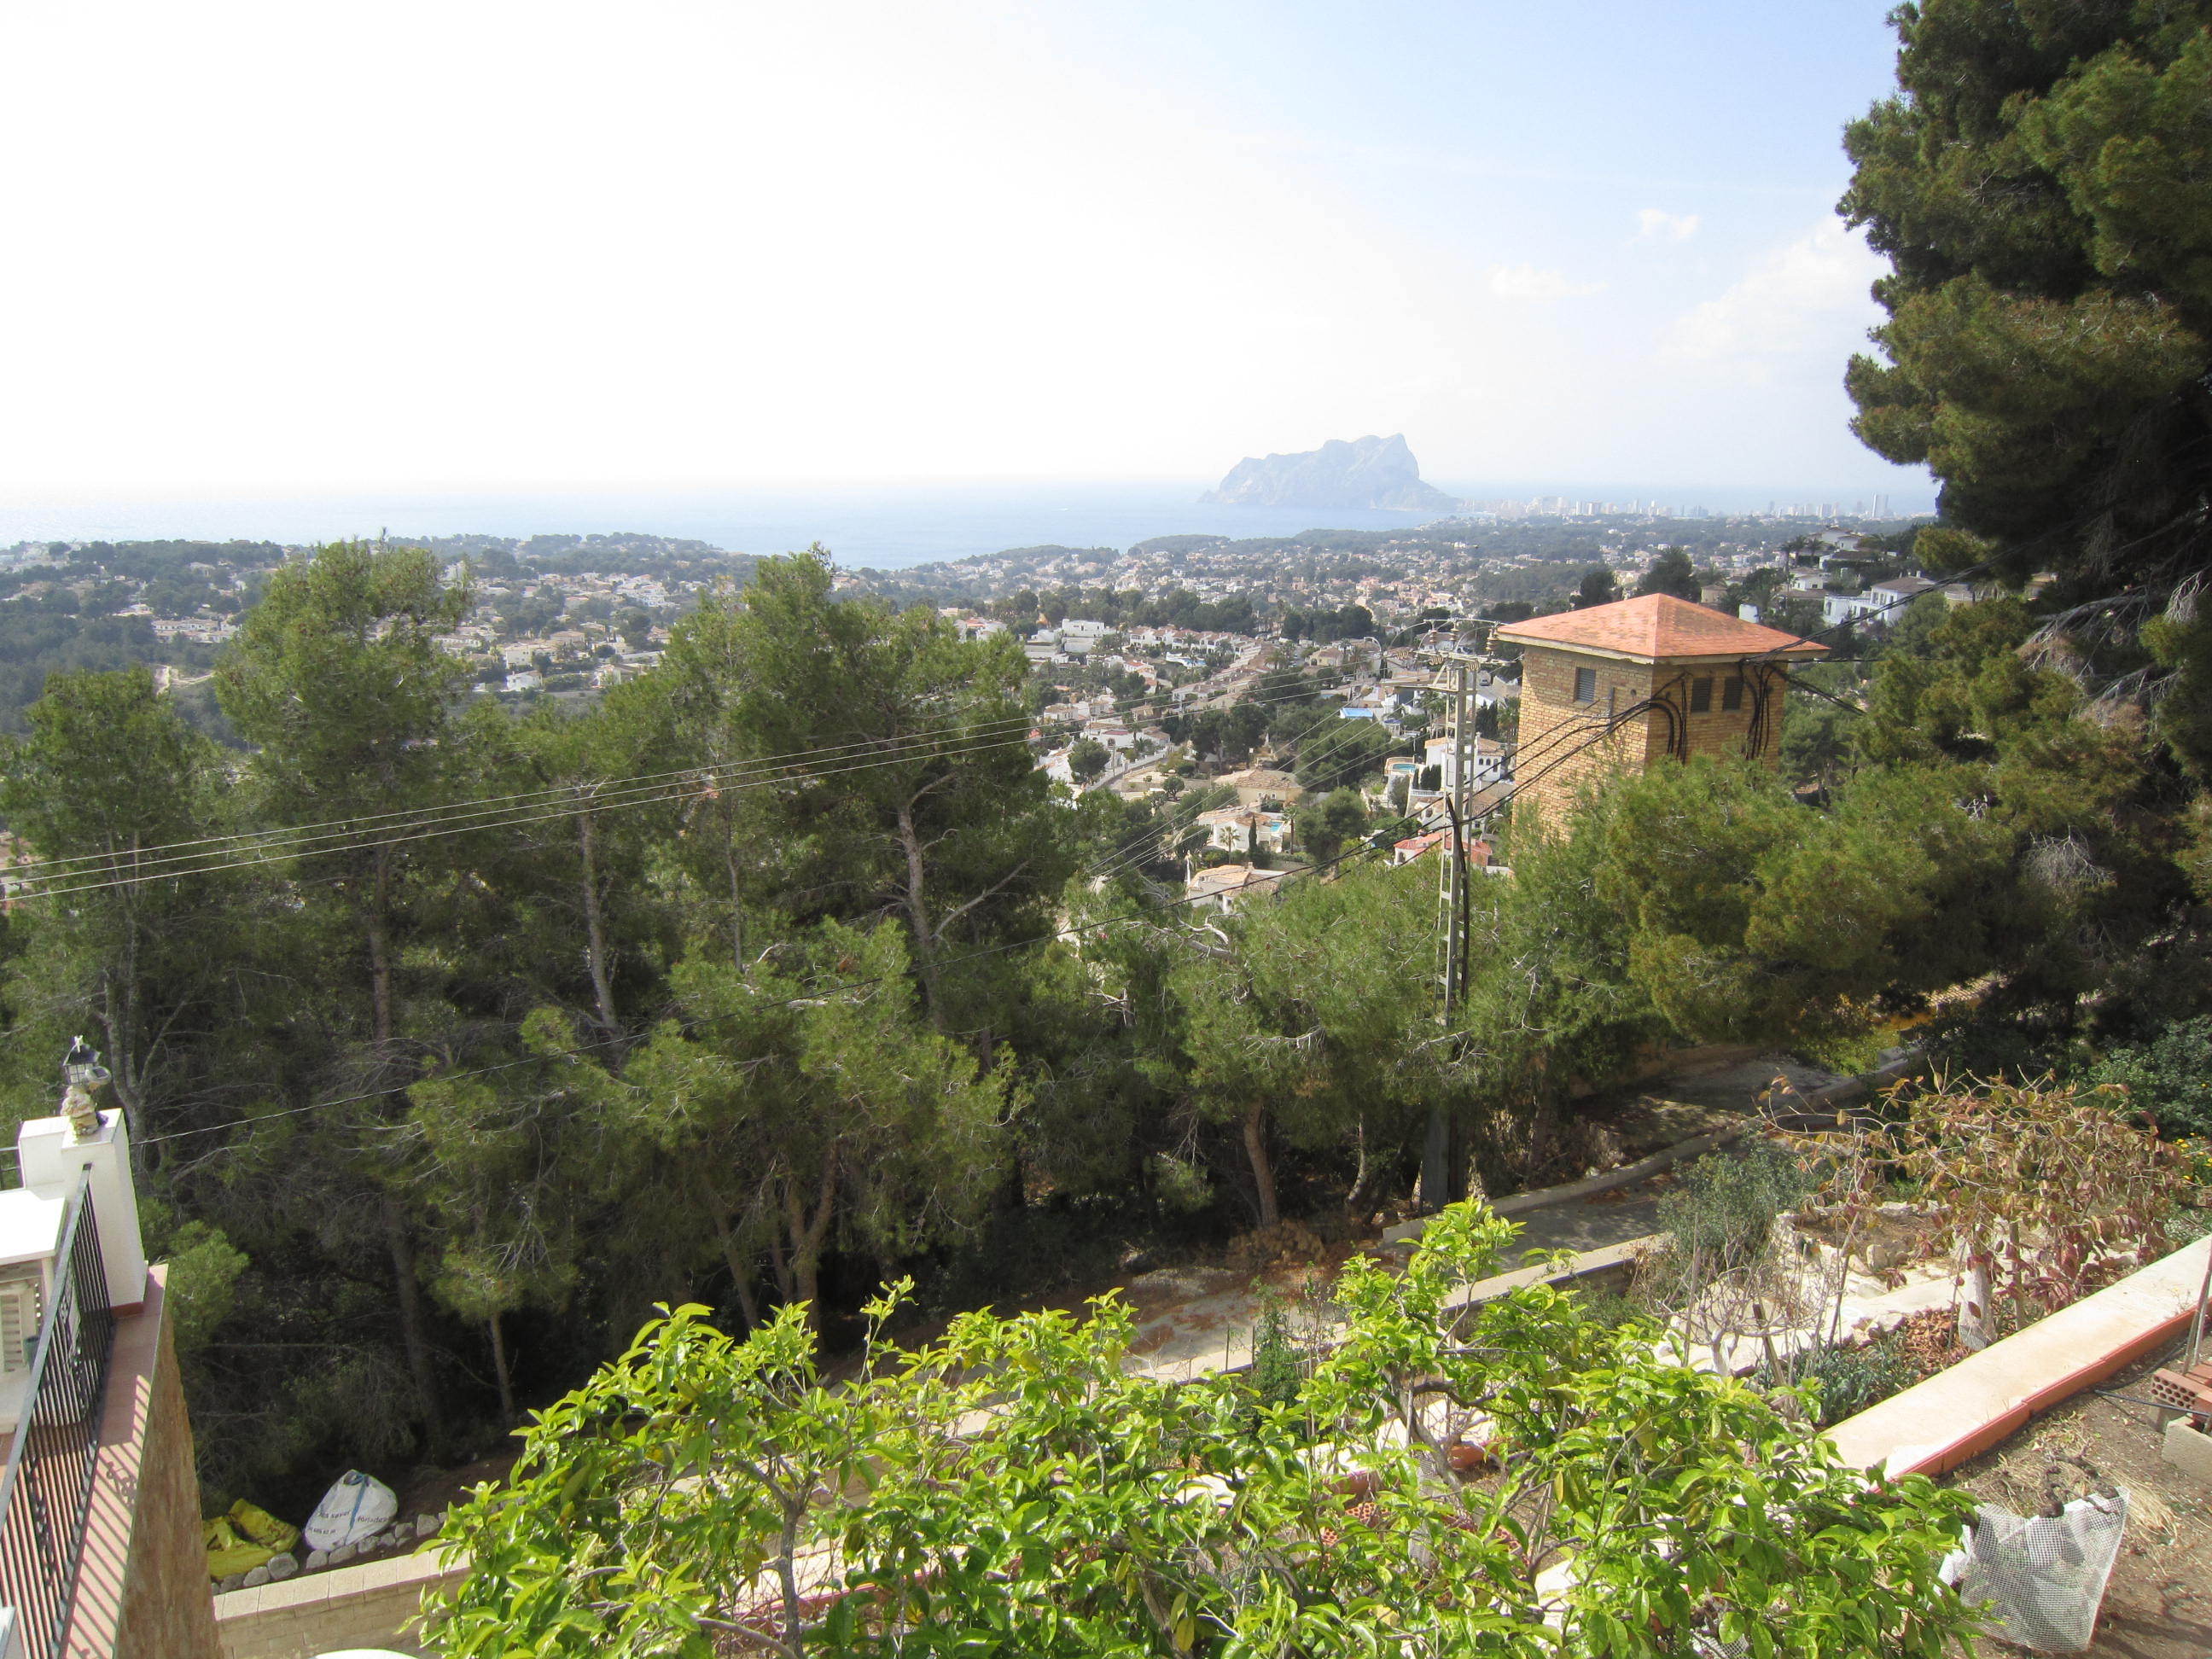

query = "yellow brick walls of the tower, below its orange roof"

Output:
[[1513, 646, 1783, 825]]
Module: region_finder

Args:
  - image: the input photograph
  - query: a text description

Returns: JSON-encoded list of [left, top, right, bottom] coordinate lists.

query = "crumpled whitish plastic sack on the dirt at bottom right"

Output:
[[1958, 1493, 2128, 1652]]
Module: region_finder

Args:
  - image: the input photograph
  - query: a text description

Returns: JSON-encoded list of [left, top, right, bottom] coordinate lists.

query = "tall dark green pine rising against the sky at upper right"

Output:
[[1841, 0, 2212, 777]]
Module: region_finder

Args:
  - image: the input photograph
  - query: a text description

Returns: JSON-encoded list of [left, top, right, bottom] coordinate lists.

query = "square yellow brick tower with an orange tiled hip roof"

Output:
[[1498, 593, 1827, 825]]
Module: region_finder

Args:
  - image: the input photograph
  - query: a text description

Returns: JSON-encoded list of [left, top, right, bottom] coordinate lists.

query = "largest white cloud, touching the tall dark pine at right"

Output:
[[1659, 219, 1887, 385]]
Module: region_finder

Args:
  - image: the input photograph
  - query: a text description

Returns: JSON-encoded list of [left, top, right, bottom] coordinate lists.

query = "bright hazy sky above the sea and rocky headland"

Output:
[[0, 0, 1927, 502]]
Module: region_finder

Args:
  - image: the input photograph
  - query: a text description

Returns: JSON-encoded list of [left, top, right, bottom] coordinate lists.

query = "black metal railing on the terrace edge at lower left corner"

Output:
[[0, 1173, 115, 1659]]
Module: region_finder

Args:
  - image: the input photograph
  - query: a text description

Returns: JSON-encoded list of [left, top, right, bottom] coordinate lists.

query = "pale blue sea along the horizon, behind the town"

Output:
[[0, 478, 1913, 571]]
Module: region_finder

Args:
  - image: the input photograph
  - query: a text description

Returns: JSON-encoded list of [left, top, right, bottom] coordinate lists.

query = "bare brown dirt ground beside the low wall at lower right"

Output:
[[1944, 1353, 2212, 1659]]
